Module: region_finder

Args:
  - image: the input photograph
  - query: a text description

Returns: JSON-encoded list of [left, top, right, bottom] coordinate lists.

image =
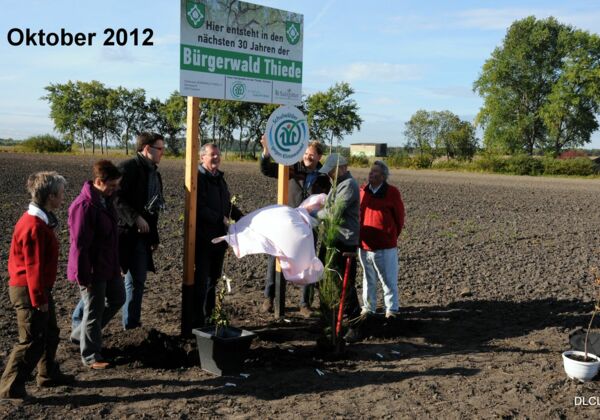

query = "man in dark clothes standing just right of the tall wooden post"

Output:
[[197, 143, 243, 328]]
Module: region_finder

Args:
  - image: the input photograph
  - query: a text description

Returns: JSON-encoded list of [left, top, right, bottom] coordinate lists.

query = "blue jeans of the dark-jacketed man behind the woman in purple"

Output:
[[123, 237, 149, 330]]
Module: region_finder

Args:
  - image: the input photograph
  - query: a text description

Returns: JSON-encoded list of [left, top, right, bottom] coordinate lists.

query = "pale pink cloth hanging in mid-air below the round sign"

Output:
[[213, 198, 324, 284]]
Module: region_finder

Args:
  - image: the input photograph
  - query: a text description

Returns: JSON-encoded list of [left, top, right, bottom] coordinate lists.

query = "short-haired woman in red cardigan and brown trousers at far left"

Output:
[[0, 172, 73, 398]]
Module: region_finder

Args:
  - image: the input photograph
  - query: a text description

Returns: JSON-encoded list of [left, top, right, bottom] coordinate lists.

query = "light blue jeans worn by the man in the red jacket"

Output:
[[358, 248, 400, 312]]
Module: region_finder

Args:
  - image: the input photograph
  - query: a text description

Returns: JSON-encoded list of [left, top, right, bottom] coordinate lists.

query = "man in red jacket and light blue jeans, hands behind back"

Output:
[[358, 160, 404, 318]]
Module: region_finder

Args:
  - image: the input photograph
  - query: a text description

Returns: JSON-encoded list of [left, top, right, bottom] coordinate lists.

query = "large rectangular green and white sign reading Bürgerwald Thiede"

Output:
[[180, 0, 304, 105]]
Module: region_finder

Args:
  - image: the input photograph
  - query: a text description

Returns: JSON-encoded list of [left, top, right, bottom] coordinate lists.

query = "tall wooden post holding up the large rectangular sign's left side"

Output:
[[181, 96, 200, 336]]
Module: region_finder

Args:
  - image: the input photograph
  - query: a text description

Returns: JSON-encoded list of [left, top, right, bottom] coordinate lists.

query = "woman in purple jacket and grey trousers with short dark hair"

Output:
[[67, 160, 125, 369]]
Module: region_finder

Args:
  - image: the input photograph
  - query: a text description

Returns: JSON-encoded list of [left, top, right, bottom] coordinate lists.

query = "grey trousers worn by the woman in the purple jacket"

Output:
[[71, 277, 125, 365]]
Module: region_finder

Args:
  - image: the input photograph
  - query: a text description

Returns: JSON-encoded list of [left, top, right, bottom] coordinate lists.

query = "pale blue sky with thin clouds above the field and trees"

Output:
[[0, 0, 600, 148]]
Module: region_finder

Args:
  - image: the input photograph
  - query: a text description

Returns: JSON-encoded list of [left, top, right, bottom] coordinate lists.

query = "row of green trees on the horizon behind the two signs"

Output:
[[43, 81, 362, 155]]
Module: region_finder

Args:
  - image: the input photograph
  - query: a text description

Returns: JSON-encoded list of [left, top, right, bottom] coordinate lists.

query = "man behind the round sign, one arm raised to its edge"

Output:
[[260, 136, 331, 317]]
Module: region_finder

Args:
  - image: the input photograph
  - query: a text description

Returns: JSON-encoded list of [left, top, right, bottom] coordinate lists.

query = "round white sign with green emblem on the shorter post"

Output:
[[265, 106, 308, 166]]
